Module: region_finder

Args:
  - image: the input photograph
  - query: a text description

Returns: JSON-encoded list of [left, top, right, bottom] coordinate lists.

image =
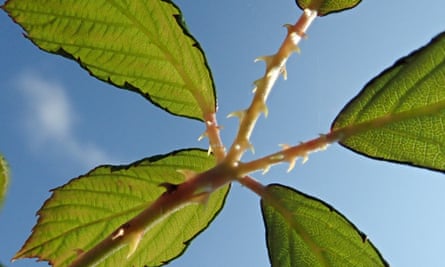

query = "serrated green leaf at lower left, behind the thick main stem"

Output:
[[14, 149, 228, 266]]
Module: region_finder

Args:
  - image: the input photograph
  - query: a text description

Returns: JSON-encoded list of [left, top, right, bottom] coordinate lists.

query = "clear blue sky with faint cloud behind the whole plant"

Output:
[[0, 0, 445, 267]]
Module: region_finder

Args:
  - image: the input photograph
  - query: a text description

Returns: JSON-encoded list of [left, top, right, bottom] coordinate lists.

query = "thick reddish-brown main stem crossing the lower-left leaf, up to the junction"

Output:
[[69, 164, 234, 267]]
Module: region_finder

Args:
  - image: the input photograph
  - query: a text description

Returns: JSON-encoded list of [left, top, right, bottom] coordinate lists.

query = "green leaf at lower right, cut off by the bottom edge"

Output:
[[261, 184, 388, 267]]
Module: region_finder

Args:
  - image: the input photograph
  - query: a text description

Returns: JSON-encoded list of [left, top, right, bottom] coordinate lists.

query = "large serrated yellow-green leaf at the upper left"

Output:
[[3, 0, 216, 120]]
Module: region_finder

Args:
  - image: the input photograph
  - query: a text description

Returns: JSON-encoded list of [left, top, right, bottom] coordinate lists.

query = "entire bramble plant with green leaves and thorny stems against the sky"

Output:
[[0, 0, 445, 266]]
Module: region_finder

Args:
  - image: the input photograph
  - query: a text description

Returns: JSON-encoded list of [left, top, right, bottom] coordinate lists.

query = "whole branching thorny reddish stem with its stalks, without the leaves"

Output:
[[70, 10, 317, 267]]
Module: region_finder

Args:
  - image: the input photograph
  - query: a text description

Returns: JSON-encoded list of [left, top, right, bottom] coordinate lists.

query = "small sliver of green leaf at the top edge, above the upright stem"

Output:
[[295, 0, 361, 16]]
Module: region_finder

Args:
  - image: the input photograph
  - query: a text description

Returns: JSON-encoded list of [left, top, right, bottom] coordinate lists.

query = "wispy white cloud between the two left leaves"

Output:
[[17, 72, 115, 167]]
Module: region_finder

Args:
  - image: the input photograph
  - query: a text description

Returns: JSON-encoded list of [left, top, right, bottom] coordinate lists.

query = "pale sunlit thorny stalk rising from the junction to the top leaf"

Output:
[[226, 9, 317, 163]]
